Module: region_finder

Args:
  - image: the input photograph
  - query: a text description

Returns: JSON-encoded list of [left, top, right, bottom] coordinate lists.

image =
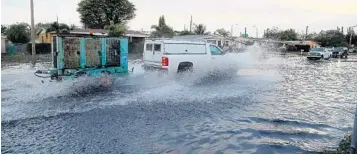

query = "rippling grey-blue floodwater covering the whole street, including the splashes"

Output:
[[1, 46, 357, 153]]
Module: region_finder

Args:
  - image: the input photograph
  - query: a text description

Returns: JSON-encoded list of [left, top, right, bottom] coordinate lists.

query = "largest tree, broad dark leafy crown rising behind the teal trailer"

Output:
[[77, 0, 136, 29]]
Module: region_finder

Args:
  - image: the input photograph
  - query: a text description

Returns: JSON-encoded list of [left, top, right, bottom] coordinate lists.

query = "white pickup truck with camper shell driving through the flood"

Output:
[[143, 40, 237, 74]]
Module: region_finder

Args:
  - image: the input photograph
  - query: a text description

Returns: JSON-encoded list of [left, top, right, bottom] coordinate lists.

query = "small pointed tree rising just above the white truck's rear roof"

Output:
[[151, 16, 175, 38]]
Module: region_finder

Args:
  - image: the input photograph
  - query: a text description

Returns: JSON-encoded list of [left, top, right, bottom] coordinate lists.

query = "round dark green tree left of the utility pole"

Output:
[[6, 23, 30, 43]]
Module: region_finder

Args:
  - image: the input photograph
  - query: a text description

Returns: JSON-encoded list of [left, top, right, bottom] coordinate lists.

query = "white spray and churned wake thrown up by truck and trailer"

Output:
[[1, 45, 272, 120]]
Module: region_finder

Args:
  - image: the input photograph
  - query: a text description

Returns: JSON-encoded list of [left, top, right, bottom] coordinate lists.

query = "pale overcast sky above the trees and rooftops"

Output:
[[1, 0, 357, 36]]
